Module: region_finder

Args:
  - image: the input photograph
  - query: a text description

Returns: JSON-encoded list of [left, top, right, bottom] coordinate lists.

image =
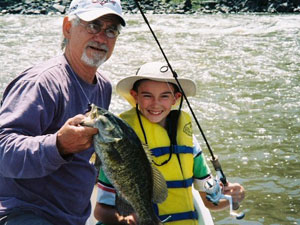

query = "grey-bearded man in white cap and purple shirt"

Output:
[[0, 0, 125, 225]]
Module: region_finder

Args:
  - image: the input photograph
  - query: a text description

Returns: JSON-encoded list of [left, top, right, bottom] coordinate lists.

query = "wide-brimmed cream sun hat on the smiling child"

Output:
[[116, 62, 196, 107]]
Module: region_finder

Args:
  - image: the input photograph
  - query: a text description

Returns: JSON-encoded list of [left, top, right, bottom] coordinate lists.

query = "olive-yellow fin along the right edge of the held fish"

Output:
[[143, 144, 168, 203]]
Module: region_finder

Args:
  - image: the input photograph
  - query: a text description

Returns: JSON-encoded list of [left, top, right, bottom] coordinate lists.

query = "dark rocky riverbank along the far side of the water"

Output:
[[0, 0, 300, 15]]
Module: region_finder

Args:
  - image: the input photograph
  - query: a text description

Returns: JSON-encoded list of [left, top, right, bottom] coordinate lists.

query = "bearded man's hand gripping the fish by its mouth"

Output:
[[56, 114, 98, 156]]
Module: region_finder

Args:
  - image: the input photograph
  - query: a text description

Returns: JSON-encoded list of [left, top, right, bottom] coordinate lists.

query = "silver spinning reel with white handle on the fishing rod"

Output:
[[204, 166, 245, 220]]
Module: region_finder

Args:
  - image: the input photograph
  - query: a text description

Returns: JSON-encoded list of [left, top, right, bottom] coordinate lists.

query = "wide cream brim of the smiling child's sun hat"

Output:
[[116, 75, 196, 107]]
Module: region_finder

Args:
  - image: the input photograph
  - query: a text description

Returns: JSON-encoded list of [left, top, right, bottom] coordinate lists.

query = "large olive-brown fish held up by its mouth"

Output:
[[82, 105, 168, 225]]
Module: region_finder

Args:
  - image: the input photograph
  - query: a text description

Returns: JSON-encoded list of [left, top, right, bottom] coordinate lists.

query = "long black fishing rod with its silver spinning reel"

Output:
[[134, 0, 245, 219]]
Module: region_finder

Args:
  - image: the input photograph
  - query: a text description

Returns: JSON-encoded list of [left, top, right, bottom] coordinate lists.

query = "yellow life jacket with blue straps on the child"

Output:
[[120, 108, 198, 225]]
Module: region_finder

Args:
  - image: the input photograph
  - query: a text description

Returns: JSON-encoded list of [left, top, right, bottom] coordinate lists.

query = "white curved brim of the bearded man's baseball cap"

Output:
[[76, 8, 126, 27]]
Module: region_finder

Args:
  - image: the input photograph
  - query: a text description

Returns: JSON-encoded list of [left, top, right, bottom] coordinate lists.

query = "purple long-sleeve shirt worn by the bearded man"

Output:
[[0, 55, 112, 225]]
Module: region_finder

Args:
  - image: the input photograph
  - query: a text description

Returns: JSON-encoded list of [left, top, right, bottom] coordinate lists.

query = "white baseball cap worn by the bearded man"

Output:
[[68, 0, 126, 26]]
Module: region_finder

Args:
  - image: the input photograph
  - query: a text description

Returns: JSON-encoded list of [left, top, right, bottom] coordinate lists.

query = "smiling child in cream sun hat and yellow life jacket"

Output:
[[94, 62, 244, 225]]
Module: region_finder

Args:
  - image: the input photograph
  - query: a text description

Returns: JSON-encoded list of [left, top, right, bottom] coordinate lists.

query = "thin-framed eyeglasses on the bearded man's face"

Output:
[[79, 20, 120, 38]]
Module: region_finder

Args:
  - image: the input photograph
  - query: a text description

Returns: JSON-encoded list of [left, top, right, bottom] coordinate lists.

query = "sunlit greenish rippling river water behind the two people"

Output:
[[0, 14, 300, 225]]
